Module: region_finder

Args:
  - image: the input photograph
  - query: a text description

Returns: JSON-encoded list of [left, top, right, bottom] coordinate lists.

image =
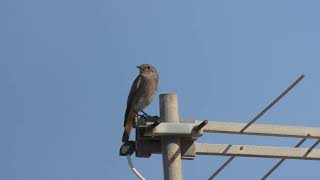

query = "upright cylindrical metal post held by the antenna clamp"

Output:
[[160, 94, 182, 180]]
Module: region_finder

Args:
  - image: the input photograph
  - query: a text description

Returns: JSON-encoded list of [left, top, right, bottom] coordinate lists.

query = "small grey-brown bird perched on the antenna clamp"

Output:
[[122, 64, 159, 142]]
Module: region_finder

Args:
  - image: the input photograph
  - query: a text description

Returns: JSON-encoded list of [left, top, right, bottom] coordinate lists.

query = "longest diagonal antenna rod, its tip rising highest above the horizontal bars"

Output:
[[209, 74, 304, 180]]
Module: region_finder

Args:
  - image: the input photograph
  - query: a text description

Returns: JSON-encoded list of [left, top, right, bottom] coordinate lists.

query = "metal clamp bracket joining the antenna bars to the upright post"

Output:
[[131, 118, 208, 160]]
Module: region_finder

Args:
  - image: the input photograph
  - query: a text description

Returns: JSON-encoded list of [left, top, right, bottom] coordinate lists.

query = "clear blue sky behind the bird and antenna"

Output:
[[0, 0, 320, 180]]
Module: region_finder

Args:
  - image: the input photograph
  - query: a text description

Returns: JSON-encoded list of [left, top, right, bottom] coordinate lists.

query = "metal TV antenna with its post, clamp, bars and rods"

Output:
[[120, 75, 320, 180]]
